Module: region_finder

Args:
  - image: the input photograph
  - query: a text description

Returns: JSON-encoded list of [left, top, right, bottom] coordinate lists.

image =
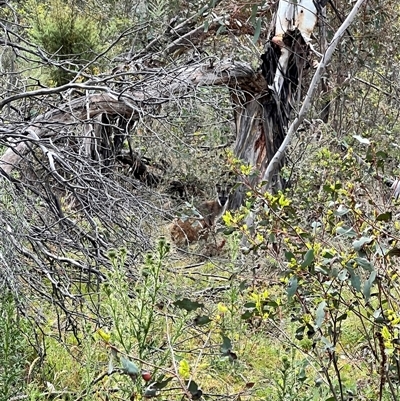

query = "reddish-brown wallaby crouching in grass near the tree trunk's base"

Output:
[[170, 185, 231, 245]]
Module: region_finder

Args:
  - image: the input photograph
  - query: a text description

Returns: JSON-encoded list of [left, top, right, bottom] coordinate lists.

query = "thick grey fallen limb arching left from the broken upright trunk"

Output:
[[0, 60, 256, 174]]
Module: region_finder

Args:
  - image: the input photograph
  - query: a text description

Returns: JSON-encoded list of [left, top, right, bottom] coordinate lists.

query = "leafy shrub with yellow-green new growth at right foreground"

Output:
[[224, 143, 400, 400]]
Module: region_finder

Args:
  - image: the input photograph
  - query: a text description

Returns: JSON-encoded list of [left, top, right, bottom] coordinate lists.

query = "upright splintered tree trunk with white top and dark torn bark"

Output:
[[231, 0, 326, 207]]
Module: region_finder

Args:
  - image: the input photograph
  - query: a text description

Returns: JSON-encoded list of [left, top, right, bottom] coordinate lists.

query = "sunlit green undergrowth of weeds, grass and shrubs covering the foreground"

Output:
[[1, 141, 400, 401]]
